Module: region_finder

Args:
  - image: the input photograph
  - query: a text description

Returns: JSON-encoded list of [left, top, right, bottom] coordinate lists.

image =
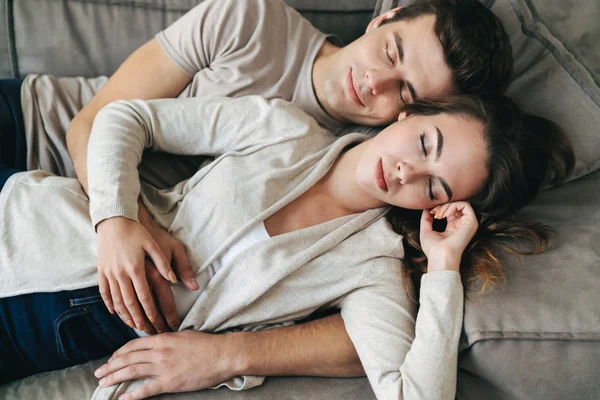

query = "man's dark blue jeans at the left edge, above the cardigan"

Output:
[[0, 79, 27, 190]]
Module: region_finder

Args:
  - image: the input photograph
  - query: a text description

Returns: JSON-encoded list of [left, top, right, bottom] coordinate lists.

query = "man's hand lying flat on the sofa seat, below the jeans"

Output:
[[94, 330, 236, 400]]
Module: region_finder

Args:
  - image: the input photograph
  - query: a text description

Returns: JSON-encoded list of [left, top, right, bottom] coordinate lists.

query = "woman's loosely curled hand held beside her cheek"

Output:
[[420, 201, 479, 271]]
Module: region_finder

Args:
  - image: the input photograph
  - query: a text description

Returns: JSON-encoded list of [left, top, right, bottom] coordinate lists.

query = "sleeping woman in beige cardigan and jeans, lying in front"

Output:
[[0, 97, 573, 398]]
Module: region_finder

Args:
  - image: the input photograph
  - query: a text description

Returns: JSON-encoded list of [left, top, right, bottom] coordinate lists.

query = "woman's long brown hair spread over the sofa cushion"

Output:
[[387, 96, 575, 298]]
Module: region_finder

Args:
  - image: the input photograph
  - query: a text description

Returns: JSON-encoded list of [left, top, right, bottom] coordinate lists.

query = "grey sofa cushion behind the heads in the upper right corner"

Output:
[[374, 0, 600, 179]]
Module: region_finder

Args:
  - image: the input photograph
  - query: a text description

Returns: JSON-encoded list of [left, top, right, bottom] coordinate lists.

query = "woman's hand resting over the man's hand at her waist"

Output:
[[98, 217, 192, 332]]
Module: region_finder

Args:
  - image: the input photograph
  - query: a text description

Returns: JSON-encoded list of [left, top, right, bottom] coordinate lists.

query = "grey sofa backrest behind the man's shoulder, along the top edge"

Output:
[[0, 0, 375, 78]]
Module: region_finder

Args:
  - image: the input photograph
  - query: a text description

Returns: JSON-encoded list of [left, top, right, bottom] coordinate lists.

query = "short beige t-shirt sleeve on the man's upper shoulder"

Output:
[[156, 0, 269, 78]]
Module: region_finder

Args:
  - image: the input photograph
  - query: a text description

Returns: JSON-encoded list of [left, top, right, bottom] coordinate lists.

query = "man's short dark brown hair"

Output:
[[382, 0, 512, 94]]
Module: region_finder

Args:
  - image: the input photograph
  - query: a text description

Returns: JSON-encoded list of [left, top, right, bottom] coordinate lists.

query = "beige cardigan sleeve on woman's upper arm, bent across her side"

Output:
[[88, 96, 323, 226]]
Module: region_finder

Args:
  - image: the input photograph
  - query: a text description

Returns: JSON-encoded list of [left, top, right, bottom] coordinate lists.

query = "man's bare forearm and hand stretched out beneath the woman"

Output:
[[94, 314, 365, 400]]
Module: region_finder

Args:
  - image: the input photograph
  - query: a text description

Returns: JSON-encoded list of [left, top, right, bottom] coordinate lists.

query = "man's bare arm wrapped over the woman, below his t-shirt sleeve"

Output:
[[67, 39, 190, 192]]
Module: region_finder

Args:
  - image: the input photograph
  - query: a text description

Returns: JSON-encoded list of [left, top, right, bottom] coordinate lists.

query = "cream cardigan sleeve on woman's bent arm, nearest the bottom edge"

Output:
[[341, 265, 464, 400]]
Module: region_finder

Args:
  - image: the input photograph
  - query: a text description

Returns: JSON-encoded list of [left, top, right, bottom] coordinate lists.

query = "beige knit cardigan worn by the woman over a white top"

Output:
[[0, 97, 463, 399]]
